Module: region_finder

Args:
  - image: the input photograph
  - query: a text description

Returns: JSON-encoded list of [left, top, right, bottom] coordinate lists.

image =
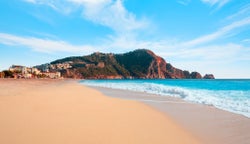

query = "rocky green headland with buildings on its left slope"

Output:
[[0, 49, 214, 79]]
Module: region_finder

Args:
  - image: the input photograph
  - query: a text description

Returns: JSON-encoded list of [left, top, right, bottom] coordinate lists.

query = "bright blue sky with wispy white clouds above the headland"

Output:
[[0, 0, 250, 78]]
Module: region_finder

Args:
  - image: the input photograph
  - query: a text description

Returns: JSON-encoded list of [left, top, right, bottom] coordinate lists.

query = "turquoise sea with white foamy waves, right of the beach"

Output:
[[80, 79, 250, 118]]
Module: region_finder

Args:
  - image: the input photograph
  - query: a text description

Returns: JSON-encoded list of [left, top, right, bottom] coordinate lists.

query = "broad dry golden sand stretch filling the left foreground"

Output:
[[0, 80, 198, 144]]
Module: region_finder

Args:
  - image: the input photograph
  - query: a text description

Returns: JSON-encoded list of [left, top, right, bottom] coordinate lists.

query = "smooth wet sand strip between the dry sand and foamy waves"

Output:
[[91, 86, 250, 144]]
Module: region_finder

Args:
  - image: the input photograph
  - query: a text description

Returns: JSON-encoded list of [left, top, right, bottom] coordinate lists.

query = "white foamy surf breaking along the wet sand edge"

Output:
[[82, 81, 250, 118]]
